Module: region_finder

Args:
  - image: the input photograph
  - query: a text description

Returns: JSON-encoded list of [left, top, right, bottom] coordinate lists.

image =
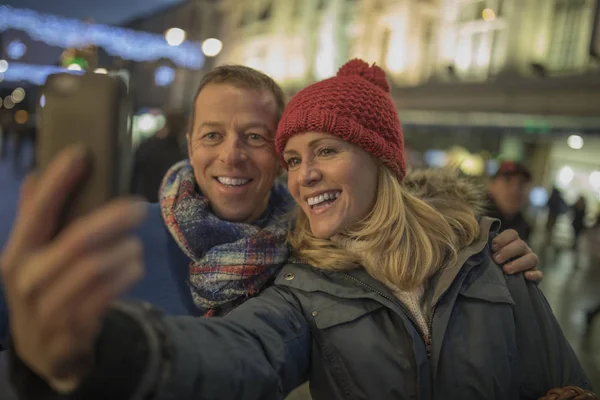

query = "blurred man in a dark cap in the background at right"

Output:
[[488, 161, 531, 241]]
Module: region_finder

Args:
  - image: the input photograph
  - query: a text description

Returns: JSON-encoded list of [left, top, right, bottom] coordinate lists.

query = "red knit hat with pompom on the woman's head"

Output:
[[275, 59, 406, 180]]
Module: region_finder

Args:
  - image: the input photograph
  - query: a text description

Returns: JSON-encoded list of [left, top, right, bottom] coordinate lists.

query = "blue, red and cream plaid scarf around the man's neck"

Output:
[[159, 160, 293, 316]]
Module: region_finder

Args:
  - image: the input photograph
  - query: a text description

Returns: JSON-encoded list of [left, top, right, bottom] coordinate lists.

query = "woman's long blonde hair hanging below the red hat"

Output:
[[289, 164, 483, 290]]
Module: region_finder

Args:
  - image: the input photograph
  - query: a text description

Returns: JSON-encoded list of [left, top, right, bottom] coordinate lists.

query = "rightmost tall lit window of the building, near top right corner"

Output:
[[548, 0, 587, 70]]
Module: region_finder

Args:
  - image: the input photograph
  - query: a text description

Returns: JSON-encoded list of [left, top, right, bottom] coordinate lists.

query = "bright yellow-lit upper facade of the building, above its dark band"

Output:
[[219, 0, 600, 93]]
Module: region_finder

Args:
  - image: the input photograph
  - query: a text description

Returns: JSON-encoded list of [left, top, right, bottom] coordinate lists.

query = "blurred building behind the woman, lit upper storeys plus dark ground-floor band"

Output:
[[218, 0, 600, 188]]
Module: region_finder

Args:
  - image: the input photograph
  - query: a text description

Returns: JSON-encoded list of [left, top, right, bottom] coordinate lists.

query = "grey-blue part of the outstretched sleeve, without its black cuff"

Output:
[[158, 287, 311, 400]]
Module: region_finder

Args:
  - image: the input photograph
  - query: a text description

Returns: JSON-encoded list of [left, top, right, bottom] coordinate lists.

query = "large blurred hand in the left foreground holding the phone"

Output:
[[0, 146, 145, 389]]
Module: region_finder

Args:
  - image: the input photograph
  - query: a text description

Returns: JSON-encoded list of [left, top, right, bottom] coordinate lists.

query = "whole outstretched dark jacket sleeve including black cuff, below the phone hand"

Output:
[[10, 287, 311, 400]]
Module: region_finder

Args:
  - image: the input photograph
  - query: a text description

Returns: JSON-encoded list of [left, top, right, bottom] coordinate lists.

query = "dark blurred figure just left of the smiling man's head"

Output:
[[131, 111, 186, 203]]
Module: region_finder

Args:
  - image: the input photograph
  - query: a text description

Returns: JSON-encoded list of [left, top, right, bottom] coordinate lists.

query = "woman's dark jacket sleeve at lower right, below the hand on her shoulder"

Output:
[[506, 274, 592, 399]]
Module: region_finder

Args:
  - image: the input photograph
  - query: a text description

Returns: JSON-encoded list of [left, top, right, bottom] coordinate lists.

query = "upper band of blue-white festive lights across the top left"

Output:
[[0, 6, 204, 69]]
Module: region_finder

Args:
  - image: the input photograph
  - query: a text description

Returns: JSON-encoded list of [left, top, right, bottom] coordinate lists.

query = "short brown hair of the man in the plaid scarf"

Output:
[[189, 65, 285, 133]]
